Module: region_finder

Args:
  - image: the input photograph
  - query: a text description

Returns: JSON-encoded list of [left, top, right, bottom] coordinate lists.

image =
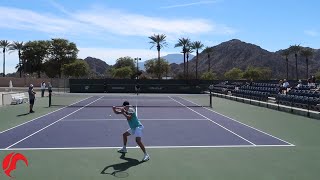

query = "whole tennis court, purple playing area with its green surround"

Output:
[[0, 94, 320, 179]]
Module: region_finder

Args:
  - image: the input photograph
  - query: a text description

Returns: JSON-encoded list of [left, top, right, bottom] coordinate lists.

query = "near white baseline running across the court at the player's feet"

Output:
[[0, 145, 293, 151]]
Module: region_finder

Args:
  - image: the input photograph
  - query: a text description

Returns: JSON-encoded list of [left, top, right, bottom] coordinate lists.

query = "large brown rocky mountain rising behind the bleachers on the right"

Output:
[[171, 39, 320, 79]]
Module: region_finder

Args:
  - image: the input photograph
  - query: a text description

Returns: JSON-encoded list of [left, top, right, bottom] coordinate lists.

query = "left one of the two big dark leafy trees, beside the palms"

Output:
[[21, 40, 50, 78]]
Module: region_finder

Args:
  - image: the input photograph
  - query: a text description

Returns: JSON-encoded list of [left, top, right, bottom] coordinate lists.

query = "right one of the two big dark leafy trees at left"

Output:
[[49, 39, 79, 78]]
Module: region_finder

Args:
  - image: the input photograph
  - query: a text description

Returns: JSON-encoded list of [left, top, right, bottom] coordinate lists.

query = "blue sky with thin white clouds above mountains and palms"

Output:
[[0, 0, 320, 73]]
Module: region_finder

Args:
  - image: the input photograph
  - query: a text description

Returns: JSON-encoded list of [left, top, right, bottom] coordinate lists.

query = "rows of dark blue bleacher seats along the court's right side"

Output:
[[213, 81, 320, 111]]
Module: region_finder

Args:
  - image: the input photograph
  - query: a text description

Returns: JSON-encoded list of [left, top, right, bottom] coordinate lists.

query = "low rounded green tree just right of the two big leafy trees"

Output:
[[62, 59, 90, 77]]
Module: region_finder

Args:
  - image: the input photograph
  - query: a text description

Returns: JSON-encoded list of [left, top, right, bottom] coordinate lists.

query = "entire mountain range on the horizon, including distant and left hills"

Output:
[[85, 39, 320, 79]]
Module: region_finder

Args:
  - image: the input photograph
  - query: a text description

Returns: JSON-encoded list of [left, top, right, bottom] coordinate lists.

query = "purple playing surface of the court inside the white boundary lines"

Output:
[[0, 96, 294, 150]]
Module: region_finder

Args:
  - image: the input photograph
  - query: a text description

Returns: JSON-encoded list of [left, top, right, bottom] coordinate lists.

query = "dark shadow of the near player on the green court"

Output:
[[100, 153, 143, 177]]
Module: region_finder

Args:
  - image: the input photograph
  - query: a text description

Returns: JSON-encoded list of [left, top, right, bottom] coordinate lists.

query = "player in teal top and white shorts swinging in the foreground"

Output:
[[112, 101, 150, 161]]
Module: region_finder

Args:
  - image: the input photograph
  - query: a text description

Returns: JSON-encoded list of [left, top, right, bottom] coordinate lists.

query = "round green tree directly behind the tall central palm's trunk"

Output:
[[144, 58, 170, 76]]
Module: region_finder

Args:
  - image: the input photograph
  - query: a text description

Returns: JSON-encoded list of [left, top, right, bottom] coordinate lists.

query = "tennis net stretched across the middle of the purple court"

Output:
[[51, 94, 210, 107]]
